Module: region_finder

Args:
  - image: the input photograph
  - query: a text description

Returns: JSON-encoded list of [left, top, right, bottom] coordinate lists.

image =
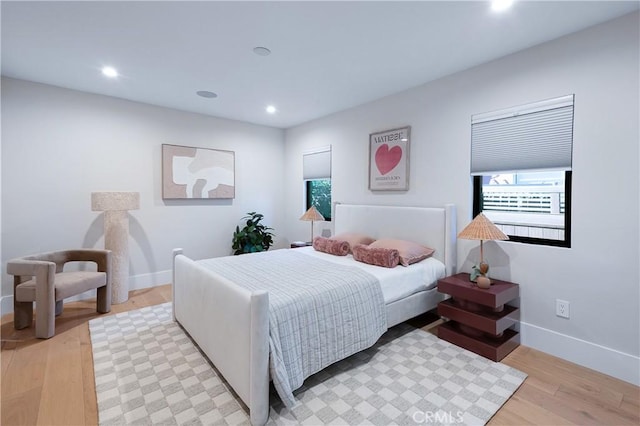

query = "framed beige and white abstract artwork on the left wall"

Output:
[[162, 145, 235, 199]]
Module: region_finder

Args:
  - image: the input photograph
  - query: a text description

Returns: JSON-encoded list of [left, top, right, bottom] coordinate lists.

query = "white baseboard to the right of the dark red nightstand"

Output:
[[520, 322, 640, 386]]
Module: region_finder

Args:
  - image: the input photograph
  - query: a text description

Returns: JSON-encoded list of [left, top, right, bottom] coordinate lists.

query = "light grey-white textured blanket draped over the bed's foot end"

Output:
[[198, 250, 387, 406]]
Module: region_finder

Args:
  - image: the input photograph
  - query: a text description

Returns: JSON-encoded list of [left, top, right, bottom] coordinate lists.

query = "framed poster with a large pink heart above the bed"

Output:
[[369, 127, 411, 191]]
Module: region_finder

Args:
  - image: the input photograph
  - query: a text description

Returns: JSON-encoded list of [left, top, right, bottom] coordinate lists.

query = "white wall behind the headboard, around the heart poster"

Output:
[[285, 13, 640, 384]]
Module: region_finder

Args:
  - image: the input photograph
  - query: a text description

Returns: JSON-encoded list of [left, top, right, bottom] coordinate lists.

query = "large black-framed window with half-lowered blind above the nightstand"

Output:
[[471, 95, 574, 247]]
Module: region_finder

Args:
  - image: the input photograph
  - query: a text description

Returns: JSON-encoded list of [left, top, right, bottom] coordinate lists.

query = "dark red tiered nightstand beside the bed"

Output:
[[438, 273, 520, 361]]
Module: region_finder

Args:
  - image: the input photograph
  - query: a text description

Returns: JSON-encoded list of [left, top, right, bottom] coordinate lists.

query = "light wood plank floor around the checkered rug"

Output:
[[0, 285, 640, 426]]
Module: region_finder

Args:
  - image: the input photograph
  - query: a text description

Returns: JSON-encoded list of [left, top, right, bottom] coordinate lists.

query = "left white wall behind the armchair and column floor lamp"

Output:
[[2, 78, 284, 302]]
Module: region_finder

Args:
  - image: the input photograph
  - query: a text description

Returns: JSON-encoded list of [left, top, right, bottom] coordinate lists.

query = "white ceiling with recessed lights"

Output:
[[1, 1, 639, 128]]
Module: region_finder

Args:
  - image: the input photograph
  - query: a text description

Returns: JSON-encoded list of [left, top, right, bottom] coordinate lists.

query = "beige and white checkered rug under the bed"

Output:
[[89, 303, 526, 426]]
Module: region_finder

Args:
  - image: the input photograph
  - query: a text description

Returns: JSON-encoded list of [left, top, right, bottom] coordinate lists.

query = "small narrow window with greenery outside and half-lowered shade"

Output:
[[302, 146, 331, 220]]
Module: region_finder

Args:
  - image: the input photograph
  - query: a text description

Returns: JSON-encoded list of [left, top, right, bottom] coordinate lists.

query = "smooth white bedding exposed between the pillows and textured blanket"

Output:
[[295, 246, 446, 305]]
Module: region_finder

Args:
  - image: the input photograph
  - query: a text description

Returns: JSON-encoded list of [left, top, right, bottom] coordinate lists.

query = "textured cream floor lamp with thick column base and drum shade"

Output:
[[91, 192, 140, 304]]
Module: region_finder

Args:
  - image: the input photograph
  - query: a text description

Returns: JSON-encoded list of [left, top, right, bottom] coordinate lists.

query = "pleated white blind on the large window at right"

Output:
[[471, 95, 574, 175]]
